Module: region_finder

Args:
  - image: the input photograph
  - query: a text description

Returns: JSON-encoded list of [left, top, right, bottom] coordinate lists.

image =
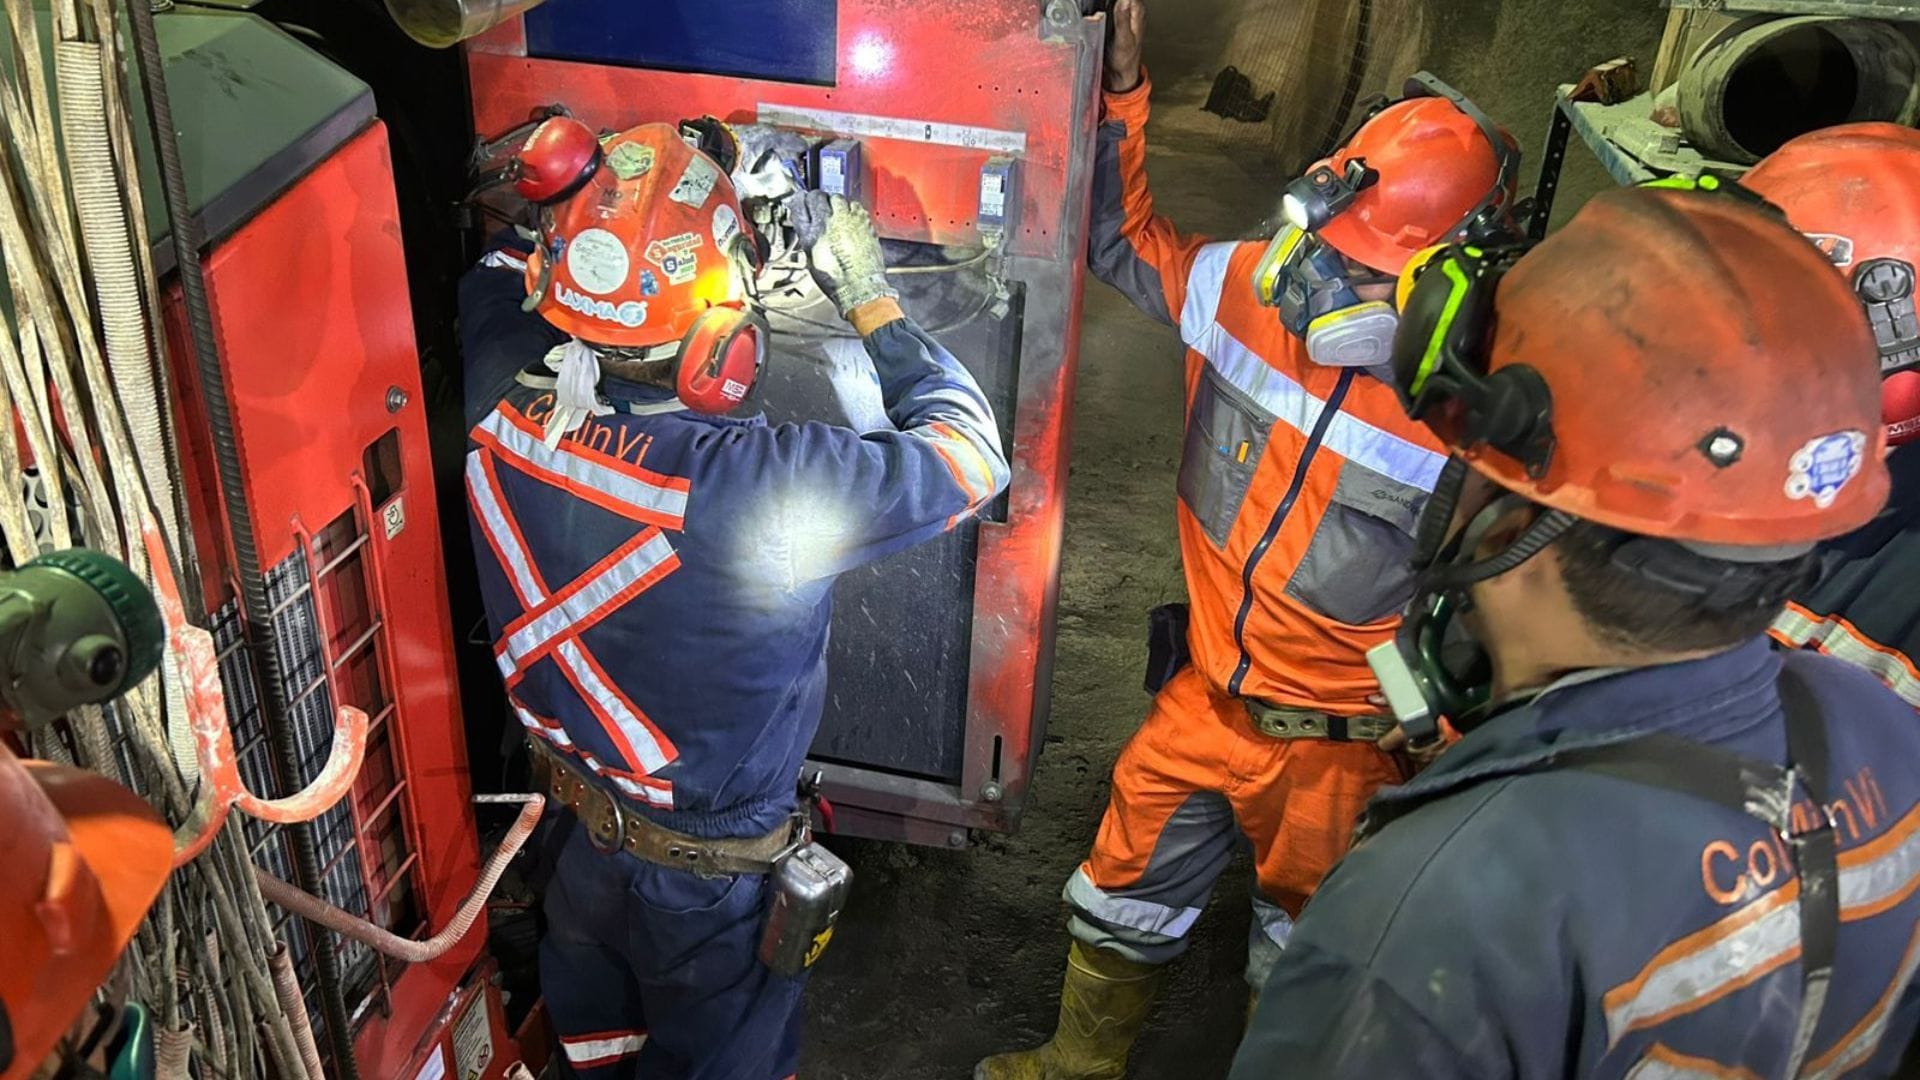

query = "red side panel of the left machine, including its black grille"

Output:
[[167, 123, 515, 1076]]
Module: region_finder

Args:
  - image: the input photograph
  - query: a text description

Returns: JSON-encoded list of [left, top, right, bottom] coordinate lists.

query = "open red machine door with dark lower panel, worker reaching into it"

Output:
[[468, 0, 1102, 844]]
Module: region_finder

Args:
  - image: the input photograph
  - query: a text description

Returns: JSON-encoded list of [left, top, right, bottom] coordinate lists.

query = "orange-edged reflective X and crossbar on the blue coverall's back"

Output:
[[467, 404, 687, 807]]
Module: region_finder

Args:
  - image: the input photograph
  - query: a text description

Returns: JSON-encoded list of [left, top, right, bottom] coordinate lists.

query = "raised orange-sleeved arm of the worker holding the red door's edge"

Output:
[[1087, 0, 1208, 327]]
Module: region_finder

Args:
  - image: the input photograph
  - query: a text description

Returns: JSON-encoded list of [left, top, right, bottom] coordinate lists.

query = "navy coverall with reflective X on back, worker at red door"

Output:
[[459, 237, 1008, 1080]]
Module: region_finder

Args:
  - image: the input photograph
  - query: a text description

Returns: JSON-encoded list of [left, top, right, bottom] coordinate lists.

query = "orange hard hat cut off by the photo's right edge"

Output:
[[1741, 123, 1920, 444]]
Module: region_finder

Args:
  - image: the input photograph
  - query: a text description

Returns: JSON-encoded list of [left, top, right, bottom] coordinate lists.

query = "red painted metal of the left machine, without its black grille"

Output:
[[167, 125, 495, 1076]]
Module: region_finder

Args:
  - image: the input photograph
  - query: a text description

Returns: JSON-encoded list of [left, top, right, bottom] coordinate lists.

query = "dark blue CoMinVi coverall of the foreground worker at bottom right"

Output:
[[1233, 638, 1920, 1080]]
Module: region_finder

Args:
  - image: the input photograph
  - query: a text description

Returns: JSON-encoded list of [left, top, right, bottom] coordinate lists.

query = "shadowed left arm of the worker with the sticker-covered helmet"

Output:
[[459, 229, 566, 427]]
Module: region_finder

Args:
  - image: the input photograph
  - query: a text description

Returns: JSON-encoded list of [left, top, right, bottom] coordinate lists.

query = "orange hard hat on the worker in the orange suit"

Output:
[[1308, 96, 1517, 273]]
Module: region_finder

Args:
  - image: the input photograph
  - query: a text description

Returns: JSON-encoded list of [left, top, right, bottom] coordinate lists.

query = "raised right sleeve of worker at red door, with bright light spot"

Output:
[[745, 298, 1008, 588]]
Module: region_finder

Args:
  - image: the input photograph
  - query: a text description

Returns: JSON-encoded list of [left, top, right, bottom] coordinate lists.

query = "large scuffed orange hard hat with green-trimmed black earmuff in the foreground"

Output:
[[1396, 188, 1889, 545]]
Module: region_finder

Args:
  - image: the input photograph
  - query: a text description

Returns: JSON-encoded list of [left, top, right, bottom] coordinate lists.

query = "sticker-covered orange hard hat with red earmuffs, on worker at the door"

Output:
[[526, 123, 749, 348]]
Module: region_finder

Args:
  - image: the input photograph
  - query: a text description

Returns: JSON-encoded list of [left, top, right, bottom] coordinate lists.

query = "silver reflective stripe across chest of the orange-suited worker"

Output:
[[1194, 327, 1446, 492]]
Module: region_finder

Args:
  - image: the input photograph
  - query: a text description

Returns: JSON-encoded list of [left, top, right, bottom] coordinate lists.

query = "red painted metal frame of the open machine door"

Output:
[[468, 0, 1104, 844]]
